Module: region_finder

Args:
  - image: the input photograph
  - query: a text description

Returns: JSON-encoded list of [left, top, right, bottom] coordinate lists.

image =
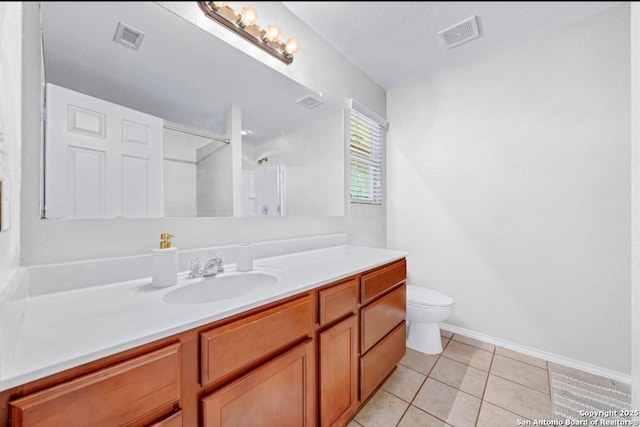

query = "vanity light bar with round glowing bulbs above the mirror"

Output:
[[198, 1, 300, 64]]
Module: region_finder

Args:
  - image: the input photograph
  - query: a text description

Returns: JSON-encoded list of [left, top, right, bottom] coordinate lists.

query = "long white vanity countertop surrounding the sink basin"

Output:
[[0, 245, 407, 391]]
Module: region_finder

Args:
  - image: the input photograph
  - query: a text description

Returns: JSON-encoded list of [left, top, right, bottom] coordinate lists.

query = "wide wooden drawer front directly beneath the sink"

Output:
[[200, 296, 313, 386]]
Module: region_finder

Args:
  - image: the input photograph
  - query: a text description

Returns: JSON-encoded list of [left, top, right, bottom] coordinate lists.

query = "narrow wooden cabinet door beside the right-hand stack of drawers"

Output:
[[319, 315, 358, 427]]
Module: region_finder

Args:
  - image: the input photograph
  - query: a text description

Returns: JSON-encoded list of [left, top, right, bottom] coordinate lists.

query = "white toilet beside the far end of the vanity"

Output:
[[407, 285, 453, 354]]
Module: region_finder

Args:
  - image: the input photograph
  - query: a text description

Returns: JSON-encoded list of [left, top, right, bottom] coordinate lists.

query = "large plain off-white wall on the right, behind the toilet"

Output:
[[387, 4, 631, 375]]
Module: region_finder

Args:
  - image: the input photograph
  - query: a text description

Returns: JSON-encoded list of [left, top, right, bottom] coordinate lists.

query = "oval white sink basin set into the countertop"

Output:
[[162, 270, 280, 304]]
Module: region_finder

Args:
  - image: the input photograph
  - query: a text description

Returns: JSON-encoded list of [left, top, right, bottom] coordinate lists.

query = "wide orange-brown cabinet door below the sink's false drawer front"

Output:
[[202, 340, 315, 427]]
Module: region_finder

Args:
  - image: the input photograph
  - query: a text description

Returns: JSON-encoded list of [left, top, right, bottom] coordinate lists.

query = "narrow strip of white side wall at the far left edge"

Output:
[[0, 2, 22, 292]]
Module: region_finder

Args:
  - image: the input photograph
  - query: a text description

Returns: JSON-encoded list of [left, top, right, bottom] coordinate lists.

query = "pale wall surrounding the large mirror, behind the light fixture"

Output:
[[21, 2, 386, 265]]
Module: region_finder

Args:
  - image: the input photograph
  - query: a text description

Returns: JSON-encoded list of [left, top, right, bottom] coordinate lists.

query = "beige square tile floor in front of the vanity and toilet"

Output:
[[347, 331, 616, 427]]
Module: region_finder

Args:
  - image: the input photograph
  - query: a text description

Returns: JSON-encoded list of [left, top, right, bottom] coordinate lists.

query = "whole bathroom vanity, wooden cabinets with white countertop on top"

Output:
[[0, 246, 406, 427]]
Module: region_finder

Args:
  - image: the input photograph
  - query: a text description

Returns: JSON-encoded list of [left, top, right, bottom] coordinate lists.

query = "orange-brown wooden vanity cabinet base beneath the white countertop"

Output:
[[0, 260, 406, 427]]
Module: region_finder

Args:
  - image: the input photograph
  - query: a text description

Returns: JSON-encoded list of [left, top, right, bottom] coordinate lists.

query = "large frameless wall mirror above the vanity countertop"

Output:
[[41, 2, 344, 218]]
